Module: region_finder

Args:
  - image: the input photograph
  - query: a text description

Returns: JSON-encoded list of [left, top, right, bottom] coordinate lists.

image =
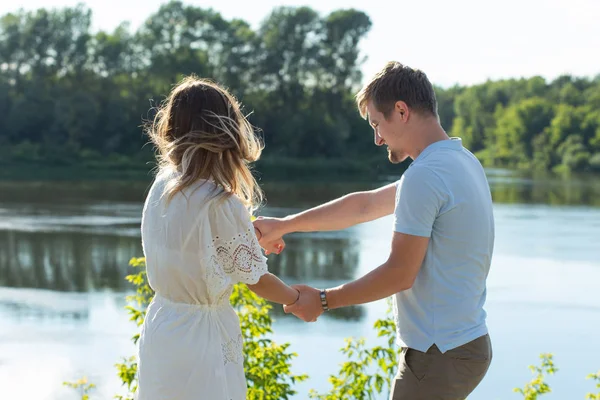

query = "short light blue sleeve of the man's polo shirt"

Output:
[[394, 166, 447, 237]]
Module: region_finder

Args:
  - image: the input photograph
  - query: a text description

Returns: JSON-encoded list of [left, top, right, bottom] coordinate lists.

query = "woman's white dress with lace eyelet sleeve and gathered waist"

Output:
[[136, 173, 267, 400]]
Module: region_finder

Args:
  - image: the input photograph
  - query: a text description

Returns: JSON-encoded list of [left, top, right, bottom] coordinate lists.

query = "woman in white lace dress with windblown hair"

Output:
[[137, 77, 299, 400]]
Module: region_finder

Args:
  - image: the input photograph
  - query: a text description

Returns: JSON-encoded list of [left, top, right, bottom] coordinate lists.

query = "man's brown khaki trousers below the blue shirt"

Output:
[[390, 335, 492, 400]]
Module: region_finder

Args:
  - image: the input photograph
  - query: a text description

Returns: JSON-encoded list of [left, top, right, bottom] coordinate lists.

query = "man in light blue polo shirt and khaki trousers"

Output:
[[255, 62, 494, 400]]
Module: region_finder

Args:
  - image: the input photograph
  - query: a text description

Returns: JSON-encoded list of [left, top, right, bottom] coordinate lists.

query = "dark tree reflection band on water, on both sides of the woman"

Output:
[[0, 230, 359, 284]]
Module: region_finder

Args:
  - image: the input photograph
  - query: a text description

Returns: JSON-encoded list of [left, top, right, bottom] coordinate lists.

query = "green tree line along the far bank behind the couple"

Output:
[[0, 1, 600, 171]]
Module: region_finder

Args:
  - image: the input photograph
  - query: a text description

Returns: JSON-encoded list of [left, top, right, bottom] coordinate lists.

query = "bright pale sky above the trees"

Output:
[[0, 0, 600, 86]]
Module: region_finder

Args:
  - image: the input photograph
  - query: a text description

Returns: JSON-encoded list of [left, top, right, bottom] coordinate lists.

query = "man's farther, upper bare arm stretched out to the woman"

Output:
[[254, 183, 396, 252]]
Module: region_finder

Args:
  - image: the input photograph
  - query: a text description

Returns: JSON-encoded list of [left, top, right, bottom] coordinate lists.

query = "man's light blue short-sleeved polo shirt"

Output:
[[394, 138, 494, 353]]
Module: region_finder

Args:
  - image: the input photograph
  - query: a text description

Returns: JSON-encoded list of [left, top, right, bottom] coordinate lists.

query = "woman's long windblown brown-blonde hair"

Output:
[[147, 76, 263, 210]]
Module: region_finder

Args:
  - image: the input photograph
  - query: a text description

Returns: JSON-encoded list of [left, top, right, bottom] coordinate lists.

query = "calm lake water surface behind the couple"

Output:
[[0, 171, 600, 400]]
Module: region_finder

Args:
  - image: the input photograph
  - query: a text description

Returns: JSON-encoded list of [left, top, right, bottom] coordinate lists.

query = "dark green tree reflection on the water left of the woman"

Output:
[[0, 230, 142, 292]]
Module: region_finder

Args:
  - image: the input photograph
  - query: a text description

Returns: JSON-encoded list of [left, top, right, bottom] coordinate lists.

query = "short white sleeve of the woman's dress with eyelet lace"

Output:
[[210, 195, 268, 285]]
